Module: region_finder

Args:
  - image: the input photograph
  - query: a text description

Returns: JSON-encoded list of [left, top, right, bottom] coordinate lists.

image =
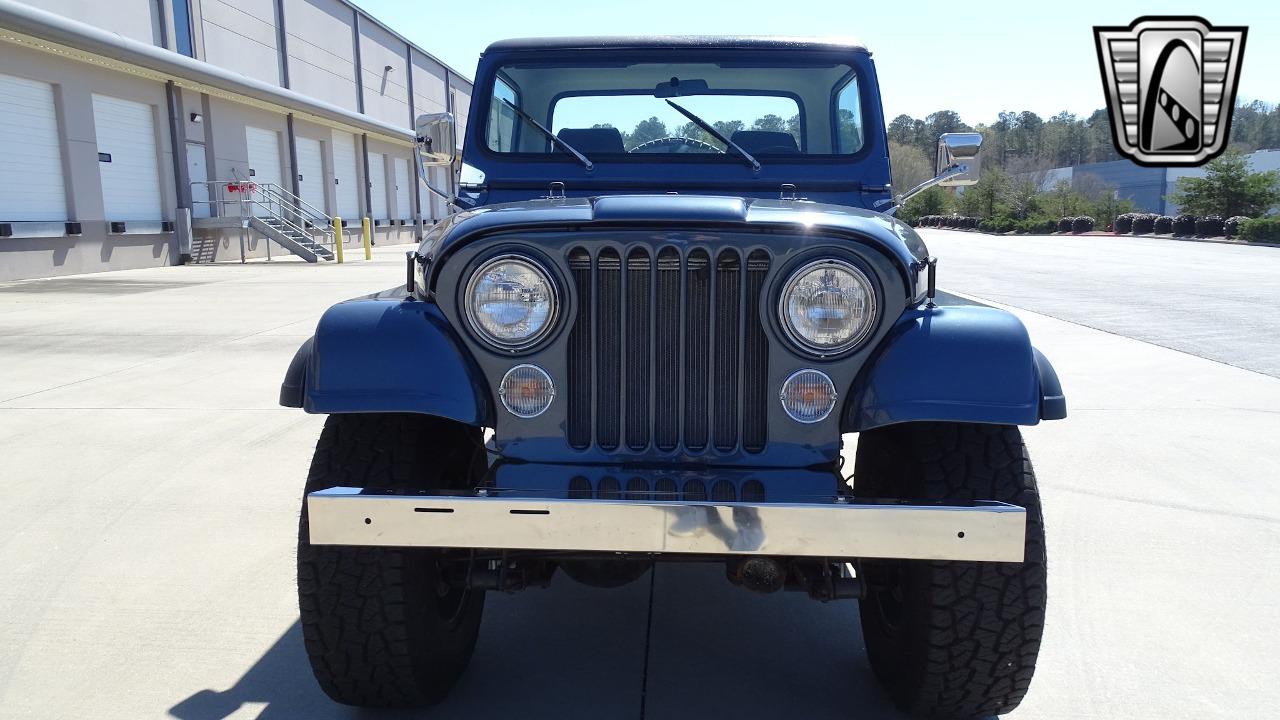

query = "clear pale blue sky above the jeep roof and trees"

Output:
[[356, 0, 1280, 124]]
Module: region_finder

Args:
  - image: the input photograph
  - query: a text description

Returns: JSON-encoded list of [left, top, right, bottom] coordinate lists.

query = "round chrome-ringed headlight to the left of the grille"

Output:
[[466, 255, 556, 350]]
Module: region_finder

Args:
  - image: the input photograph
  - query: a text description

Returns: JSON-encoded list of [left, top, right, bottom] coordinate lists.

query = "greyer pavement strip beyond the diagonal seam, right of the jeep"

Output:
[[922, 229, 1280, 377]]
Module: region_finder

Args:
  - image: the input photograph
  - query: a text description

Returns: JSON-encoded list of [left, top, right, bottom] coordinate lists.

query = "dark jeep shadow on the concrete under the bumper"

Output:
[[169, 565, 921, 720]]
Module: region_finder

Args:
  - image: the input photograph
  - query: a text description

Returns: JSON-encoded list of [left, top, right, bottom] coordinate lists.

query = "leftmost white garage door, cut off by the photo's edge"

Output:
[[0, 74, 67, 222]]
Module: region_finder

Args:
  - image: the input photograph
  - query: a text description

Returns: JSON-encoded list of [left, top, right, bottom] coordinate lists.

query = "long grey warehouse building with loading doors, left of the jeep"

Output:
[[0, 0, 471, 279]]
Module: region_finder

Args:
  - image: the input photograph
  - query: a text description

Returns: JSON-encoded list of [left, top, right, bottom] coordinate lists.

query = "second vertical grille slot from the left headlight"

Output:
[[595, 250, 622, 450]]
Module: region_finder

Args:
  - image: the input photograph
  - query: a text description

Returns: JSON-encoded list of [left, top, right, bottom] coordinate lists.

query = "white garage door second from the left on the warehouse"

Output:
[[93, 95, 164, 222]]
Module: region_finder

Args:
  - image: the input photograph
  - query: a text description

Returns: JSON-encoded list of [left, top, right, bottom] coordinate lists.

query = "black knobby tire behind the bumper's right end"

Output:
[[854, 423, 1046, 719]]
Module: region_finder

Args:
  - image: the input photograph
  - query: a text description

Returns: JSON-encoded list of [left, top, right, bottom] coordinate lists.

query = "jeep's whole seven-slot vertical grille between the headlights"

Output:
[[567, 247, 769, 454]]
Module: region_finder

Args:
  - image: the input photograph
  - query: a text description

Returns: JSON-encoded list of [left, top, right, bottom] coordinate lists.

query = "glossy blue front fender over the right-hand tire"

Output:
[[841, 306, 1066, 432]]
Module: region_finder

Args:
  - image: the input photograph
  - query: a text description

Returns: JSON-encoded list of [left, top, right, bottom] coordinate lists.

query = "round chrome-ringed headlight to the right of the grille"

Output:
[[778, 259, 876, 355]]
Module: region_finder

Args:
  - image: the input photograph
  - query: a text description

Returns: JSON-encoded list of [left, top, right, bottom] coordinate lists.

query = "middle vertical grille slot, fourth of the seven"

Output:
[[653, 247, 681, 450]]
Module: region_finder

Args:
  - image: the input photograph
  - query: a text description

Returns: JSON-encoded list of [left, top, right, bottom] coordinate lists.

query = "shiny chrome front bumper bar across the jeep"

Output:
[[307, 487, 1027, 562]]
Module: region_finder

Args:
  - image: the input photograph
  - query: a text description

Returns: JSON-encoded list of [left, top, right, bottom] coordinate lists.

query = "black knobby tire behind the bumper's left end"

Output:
[[298, 415, 484, 707]]
